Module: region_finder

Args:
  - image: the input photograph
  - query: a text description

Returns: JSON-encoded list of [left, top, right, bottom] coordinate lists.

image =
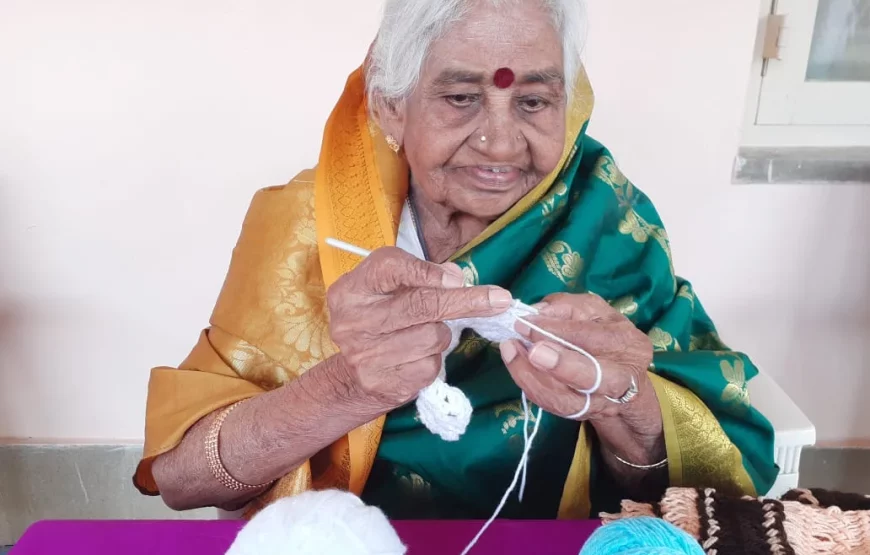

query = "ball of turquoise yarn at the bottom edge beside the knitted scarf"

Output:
[[580, 517, 704, 555]]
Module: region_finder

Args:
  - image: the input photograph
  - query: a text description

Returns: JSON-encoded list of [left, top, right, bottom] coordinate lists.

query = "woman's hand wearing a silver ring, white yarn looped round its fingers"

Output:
[[501, 293, 664, 472]]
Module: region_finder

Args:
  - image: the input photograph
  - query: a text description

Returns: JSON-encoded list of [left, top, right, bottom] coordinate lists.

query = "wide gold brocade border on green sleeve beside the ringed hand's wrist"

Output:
[[649, 373, 755, 495]]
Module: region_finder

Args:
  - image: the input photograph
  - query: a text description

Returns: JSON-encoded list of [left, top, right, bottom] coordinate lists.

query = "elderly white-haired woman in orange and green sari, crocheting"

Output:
[[135, 0, 777, 518]]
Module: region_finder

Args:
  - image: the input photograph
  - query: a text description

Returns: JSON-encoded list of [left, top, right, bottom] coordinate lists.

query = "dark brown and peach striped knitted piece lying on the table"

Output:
[[601, 488, 870, 555]]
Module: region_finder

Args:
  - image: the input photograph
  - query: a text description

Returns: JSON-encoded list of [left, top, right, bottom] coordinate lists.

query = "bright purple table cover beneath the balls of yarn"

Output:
[[10, 520, 599, 555]]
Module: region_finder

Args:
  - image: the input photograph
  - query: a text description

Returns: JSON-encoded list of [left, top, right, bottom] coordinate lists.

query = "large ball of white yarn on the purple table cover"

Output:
[[226, 490, 407, 555]]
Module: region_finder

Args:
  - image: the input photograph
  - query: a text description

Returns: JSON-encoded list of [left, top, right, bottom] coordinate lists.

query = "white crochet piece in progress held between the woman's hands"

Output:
[[417, 301, 538, 441]]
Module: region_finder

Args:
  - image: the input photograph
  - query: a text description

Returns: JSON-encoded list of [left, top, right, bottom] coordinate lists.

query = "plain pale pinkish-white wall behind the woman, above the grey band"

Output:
[[0, 0, 870, 441]]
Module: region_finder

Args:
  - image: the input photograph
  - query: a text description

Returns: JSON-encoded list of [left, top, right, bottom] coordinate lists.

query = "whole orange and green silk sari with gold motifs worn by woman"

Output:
[[134, 63, 777, 518]]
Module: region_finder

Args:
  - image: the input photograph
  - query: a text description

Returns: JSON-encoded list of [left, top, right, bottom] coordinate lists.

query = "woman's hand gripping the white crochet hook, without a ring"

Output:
[[327, 247, 512, 408]]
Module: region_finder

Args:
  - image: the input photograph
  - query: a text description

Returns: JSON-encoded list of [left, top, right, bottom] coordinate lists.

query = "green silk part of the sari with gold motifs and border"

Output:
[[363, 128, 777, 519]]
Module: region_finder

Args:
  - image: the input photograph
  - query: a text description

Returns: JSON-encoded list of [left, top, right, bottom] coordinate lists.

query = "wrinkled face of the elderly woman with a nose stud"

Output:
[[382, 1, 566, 219]]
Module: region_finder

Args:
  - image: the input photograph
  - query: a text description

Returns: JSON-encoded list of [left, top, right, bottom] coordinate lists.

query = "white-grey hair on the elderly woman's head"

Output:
[[366, 0, 586, 101]]
